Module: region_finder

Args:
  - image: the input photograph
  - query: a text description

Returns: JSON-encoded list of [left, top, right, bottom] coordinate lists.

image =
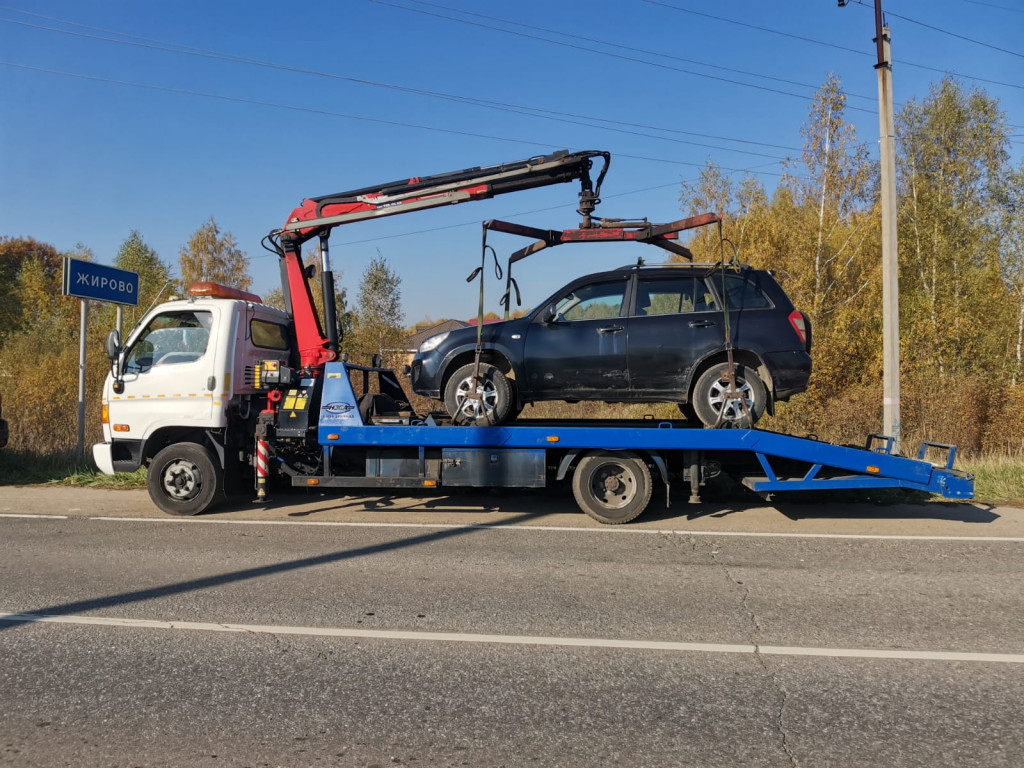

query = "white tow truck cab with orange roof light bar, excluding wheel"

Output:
[[92, 283, 291, 474]]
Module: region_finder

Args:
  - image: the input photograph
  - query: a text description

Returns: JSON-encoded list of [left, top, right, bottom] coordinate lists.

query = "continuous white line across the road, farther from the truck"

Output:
[[0, 611, 1024, 664]]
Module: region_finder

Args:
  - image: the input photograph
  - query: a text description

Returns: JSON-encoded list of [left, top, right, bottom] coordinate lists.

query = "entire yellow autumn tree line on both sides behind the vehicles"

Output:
[[0, 76, 1024, 457]]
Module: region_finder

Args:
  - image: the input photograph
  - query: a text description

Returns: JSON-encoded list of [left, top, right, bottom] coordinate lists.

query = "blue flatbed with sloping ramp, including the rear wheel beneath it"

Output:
[[276, 364, 974, 523]]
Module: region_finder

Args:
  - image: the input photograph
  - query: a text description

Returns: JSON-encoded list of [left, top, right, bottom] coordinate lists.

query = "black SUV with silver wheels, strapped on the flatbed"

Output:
[[411, 263, 811, 427]]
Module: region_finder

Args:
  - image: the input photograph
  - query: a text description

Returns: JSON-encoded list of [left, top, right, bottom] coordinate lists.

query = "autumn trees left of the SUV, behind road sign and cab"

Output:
[[0, 217, 408, 454]]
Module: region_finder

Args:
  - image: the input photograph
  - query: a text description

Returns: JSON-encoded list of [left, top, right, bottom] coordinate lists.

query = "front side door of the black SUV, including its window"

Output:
[[523, 278, 629, 400]]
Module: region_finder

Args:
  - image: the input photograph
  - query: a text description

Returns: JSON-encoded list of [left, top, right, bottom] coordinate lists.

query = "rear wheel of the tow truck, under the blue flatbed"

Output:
[[572, 451, 651, 525]]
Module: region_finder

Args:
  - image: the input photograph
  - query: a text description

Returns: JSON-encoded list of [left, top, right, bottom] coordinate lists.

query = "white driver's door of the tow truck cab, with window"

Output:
[[112, 309, 219, 428]]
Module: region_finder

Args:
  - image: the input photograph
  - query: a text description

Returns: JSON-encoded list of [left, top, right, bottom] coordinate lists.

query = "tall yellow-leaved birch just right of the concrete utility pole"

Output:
[[897, 78, 1009, 377]]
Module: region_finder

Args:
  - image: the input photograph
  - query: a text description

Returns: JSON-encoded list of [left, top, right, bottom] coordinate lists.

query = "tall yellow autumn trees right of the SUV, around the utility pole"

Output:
[[680, 77, 1024, 457]]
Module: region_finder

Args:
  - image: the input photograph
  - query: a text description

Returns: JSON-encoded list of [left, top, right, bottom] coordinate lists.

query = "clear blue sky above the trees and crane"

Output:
[[0, 0, 1024, 325]]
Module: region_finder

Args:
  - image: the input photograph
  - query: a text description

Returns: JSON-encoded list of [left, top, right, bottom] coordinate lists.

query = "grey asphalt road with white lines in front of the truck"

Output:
[[0, 487, 1024, 767]]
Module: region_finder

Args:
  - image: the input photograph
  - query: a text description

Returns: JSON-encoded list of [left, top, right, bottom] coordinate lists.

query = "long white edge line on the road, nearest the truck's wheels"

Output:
[[85, 517, 1024, 544]]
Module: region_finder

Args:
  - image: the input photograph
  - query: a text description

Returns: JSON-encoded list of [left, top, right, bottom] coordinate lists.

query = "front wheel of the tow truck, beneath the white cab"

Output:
[[145, 442, 224, 515]]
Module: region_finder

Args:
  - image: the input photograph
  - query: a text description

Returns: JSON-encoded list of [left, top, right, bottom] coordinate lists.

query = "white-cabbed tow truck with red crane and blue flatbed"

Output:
[[93, 151, 974, 524]]
